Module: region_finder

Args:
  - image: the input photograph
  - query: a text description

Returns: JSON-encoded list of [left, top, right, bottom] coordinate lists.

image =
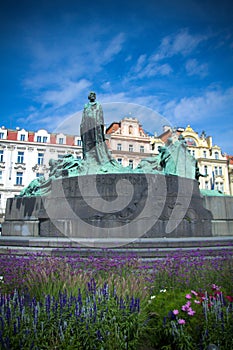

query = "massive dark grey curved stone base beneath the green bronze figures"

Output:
[[3, 174, 212, 241]]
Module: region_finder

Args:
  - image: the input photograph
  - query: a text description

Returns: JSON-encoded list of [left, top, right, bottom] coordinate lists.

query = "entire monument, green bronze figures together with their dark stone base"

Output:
[[3, 92, 212, 241]]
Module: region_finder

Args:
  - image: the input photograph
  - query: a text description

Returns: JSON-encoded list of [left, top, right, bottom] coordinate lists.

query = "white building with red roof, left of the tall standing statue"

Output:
[[0, 127, 82, 221]]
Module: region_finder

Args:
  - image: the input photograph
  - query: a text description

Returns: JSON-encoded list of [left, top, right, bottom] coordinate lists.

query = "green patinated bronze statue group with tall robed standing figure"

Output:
[[19, 91, 196, 197]]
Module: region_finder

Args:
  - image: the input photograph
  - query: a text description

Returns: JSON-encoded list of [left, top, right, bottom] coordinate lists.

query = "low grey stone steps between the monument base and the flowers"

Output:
[[0, 236, 233, 259]]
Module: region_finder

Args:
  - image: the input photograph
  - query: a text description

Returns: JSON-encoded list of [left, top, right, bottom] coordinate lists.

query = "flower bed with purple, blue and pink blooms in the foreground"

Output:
[[0, 250, 233, 350]]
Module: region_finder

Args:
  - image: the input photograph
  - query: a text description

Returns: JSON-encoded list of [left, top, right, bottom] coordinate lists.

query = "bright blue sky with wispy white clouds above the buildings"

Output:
[[0, 0, 233, 154]]
